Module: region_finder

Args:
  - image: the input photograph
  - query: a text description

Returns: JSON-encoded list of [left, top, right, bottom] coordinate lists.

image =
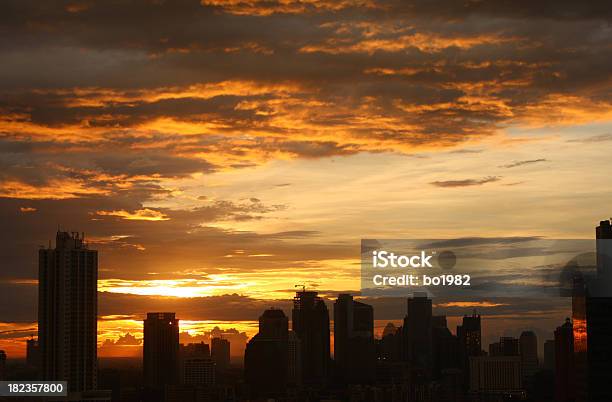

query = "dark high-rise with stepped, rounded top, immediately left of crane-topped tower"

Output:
[[244, 309, 289, 398]]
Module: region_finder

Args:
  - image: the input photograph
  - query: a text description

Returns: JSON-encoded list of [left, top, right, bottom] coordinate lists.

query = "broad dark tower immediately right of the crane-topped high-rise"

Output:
[[334, 294, 376, 384]]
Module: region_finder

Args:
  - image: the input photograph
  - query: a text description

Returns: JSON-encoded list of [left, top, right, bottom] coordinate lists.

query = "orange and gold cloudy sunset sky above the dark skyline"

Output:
[[0, 0, 612, 358]]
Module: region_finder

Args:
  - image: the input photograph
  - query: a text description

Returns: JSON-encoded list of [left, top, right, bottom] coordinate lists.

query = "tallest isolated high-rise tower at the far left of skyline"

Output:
[[38, 232, 98, 392]]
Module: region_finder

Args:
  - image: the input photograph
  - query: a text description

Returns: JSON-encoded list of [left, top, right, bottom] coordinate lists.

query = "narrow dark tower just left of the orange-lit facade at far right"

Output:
[[555, 318, 576, 402]]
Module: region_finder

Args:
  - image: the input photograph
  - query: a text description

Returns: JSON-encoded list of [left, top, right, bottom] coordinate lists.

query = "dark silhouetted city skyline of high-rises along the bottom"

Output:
[[0, 220, 612, 402]]
